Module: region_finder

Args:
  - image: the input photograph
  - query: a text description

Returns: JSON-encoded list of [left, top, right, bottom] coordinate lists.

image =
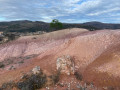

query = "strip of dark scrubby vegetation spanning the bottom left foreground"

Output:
[[0, 66, 60, 90]]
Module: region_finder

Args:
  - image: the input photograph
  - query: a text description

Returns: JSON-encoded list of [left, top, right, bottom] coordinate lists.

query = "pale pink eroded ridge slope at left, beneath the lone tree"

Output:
[[0, 28, 87, 61]]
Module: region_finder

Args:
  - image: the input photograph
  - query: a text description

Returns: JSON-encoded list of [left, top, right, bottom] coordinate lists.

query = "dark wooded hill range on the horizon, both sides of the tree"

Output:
[[0, 20, 120, 32]]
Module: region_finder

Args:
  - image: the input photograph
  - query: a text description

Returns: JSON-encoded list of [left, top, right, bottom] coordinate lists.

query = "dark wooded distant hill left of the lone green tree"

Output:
[[0, 20, 49, 32]]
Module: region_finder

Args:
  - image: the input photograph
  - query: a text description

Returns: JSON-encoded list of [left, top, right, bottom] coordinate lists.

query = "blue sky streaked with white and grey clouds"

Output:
[[0, 0, 120, 23]]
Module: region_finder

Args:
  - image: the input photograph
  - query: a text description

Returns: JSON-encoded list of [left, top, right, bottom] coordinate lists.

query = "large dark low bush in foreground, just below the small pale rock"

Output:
[[17, 74, 46, 90]]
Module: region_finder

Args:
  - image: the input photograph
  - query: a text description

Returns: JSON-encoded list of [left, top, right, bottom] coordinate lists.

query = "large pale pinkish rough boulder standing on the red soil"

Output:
[[57, 55, 75, 75]]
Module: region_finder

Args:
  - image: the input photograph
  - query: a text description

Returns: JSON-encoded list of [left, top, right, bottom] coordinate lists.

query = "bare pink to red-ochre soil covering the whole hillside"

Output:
[[0, 28, 120, 90]]
